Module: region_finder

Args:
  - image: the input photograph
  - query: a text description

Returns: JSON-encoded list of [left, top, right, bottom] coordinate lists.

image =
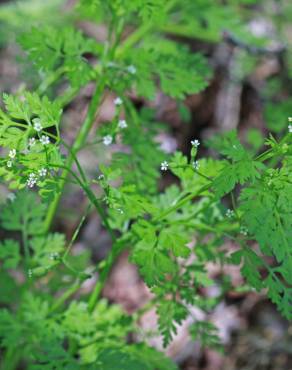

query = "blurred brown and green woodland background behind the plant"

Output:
[[0, 0, 292, 370]]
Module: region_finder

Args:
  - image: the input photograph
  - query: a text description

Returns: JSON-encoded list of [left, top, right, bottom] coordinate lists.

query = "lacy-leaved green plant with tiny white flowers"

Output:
[[0, 0, 292, 370]]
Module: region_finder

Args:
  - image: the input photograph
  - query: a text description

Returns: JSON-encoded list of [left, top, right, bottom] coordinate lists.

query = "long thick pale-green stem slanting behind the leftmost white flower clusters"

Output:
[[45, 78, 105, 231]]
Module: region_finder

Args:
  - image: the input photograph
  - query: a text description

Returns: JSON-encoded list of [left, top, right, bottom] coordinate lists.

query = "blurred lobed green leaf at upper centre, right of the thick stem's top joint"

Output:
[[123, 39, 211, 99]]
